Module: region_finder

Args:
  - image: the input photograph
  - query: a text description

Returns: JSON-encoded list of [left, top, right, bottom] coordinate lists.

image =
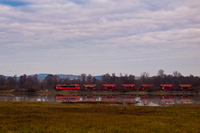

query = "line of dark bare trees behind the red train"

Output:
[[0, 69, 200, 92]]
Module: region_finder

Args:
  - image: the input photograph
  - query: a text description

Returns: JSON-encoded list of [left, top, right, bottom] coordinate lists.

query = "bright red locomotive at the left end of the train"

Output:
[[56, 84, 80, 90]]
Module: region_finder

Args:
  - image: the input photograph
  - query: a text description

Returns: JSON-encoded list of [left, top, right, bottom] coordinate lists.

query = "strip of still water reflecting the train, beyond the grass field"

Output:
[[0, 95, 200, 106]]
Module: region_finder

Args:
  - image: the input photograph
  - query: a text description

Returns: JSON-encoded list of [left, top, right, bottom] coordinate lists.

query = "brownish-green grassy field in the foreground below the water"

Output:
[[0, 101, 200, 133]]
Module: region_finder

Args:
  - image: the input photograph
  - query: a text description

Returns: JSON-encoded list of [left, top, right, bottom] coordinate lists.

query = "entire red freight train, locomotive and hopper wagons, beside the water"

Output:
[[56, 84, 192, 91]]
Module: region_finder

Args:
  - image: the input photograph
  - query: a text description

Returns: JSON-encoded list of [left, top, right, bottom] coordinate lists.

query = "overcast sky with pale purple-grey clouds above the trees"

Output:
[[0, 0, 200, 76]]
